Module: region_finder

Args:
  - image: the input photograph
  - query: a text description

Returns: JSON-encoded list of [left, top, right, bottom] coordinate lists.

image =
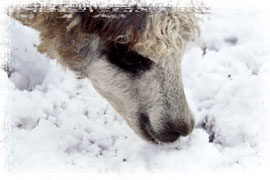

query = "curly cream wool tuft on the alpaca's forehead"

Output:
[[135, 8, 199, 61]]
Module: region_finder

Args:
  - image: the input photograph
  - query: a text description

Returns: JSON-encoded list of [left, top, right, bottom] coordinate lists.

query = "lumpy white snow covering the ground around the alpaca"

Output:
[[0, 1, 270, 176]]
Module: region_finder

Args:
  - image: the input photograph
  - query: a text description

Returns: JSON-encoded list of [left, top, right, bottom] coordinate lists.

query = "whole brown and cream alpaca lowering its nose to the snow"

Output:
[[8, 4, 199, 143]]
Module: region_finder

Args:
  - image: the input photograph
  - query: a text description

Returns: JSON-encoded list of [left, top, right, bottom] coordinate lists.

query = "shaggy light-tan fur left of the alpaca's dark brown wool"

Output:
[[8, 4, 94, 77]]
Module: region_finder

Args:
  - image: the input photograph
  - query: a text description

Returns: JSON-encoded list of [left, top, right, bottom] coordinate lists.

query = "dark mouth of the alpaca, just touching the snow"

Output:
[[139, 113, 180, 143]]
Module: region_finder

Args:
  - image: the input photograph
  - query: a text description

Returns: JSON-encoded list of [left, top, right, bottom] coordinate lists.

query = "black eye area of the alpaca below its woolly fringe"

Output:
[[102, 44, 153, 75]]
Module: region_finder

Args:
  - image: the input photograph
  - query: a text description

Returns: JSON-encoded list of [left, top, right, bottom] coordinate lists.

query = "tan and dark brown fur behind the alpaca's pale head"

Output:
[[10, 4, 150, 76]]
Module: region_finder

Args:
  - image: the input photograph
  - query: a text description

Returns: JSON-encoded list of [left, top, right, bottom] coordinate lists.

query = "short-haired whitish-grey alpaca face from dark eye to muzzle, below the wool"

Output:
[[87, 40, 194, 142]]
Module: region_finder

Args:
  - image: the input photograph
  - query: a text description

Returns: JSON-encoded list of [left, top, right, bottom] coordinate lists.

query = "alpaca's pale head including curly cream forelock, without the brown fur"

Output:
[[82, 9, 196, 142]]
